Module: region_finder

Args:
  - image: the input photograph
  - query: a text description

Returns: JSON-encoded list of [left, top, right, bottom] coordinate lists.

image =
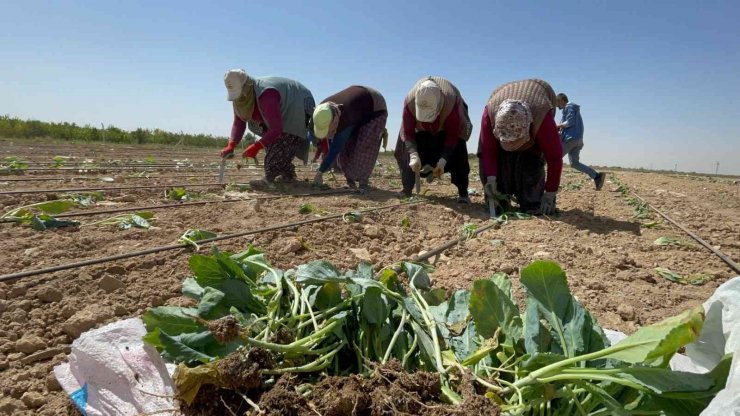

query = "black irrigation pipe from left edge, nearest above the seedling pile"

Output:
[[0, 201, 425, 282]]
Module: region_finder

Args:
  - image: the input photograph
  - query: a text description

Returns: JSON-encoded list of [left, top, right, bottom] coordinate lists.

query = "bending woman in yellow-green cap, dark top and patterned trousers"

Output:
[[312, 85, 388, 193]]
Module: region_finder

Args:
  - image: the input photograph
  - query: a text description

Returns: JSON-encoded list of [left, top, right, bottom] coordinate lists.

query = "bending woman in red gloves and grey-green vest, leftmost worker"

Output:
[[221, 69, 314, 186]]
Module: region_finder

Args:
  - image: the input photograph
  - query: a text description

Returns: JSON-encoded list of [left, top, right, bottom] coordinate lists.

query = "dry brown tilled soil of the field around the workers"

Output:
[[0, 139, 740, 415]]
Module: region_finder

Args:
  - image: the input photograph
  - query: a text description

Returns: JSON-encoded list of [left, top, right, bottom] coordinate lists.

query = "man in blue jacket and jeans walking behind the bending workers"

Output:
[[556, 92, 606, 191]]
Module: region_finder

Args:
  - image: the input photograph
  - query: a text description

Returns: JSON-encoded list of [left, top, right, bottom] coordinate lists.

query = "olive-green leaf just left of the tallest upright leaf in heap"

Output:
[[470, 280, 522, 345]]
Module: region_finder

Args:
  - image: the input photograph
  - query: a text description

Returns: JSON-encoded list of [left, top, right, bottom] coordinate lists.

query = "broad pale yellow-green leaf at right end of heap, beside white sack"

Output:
[[605, 305, 704, 364]]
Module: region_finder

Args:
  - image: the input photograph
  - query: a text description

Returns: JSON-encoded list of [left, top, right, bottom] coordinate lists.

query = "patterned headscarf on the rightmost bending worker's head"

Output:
[[493, 100, 532, 152]]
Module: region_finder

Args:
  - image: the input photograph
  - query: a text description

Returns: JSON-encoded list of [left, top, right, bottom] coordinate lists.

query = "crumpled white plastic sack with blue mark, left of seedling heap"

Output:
[[54, 318, 177, 416]]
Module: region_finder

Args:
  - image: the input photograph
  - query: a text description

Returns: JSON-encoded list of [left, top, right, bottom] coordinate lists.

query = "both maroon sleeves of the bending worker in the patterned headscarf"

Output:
[[480, 106, 563, 192]]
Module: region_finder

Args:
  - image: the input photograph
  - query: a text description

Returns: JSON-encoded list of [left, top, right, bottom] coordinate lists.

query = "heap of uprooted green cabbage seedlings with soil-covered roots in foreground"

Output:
[[143, 247, 731, 416]]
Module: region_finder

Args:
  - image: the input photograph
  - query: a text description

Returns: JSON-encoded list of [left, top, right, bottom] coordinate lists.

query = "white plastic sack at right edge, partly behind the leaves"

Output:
[[604, 276, 740, 416]]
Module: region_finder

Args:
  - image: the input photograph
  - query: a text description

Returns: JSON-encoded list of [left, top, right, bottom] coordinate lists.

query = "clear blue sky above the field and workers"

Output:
[[0, 0, 740, 174]]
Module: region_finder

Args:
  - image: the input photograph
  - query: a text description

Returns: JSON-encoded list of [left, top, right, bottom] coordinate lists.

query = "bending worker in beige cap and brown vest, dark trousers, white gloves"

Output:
[[395, 77, 472, 204]]
